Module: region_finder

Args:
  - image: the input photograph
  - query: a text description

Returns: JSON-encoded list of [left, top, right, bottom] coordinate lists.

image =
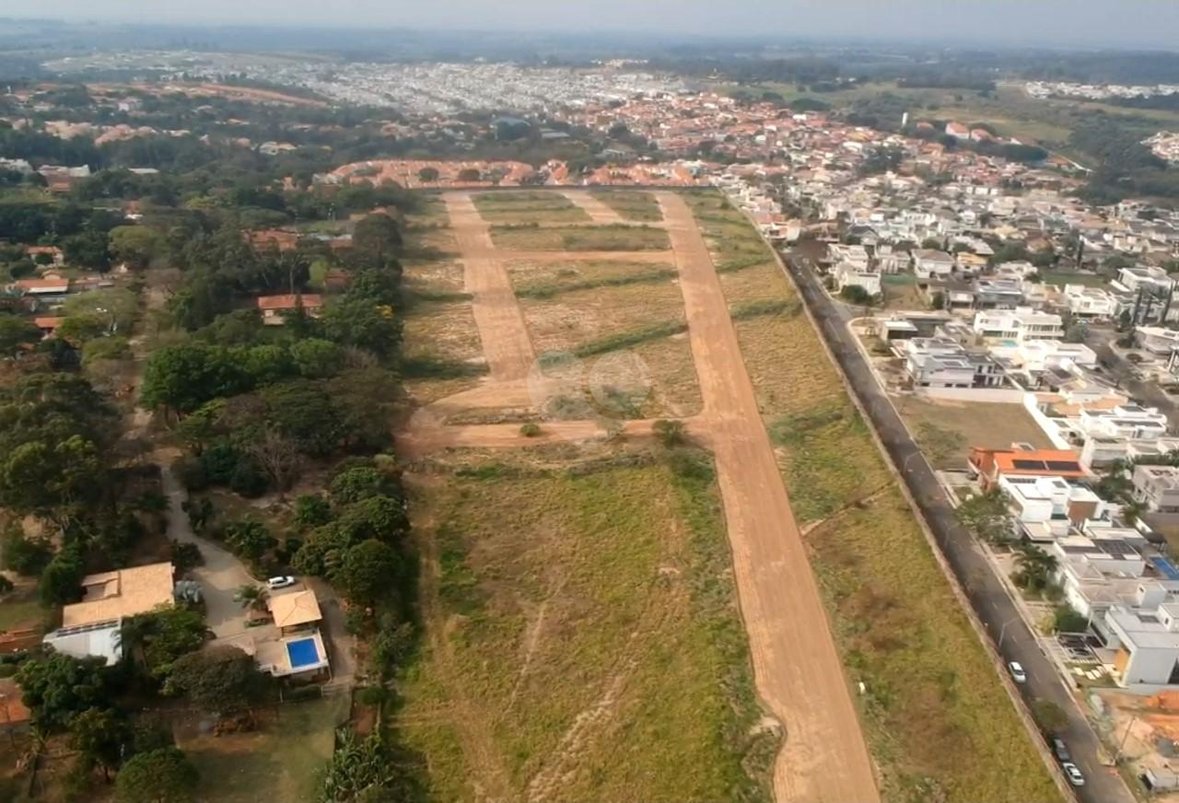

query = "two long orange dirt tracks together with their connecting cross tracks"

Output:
[[400, 192, 880, 803]]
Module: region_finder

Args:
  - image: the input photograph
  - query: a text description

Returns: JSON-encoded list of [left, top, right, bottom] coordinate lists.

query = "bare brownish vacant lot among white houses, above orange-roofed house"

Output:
[[894, 397, 1053, 469]]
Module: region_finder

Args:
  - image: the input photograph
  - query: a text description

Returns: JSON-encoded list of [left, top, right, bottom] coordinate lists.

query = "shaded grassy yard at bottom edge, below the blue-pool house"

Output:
[[177, 695, 349, 803]]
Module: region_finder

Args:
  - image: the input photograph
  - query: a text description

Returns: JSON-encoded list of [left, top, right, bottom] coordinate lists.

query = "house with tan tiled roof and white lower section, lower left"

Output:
[[44, 562, 174, 665]]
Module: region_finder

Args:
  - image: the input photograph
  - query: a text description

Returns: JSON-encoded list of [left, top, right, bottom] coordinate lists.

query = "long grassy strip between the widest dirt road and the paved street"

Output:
[[688, 195, 1059, 803]]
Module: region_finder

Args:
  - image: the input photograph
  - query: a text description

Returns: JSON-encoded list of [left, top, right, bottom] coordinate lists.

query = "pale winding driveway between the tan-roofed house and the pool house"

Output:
[[159, 460, 257, 638]]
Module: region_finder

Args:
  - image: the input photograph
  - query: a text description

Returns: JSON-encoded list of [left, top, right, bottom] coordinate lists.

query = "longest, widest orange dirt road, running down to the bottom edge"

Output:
[[658, 192, 880, 803]]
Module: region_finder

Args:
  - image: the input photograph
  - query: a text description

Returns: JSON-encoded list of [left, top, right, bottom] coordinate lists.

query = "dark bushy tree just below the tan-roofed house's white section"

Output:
[[17, 652, 108, 732]]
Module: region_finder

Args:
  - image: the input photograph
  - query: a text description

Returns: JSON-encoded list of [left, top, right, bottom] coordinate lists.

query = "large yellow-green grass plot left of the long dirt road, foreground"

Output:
[[397, 445, 777, 802]]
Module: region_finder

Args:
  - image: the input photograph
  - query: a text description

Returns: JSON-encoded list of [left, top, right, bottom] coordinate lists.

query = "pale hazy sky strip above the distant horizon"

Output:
[[0, 0, 1179, 50]]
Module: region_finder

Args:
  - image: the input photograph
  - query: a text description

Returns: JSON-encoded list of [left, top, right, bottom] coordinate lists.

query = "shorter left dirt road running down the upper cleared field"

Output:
[[442, 192, 535, 382]]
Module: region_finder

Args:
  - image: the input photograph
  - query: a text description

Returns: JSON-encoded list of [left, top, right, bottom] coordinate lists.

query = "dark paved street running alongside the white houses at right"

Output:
[[788, 252, 1134, 803]]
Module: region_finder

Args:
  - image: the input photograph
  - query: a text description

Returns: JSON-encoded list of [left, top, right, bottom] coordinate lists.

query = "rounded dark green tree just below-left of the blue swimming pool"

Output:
[[164, 645, 274, 717]]
